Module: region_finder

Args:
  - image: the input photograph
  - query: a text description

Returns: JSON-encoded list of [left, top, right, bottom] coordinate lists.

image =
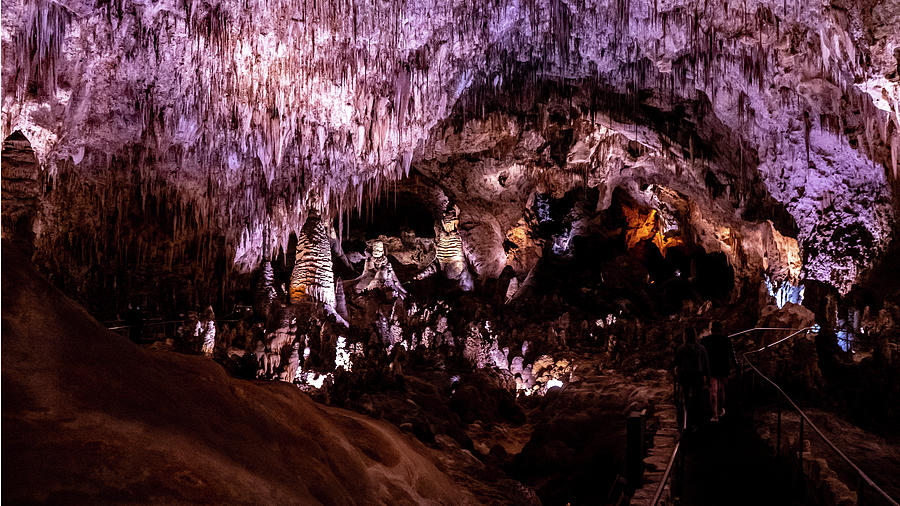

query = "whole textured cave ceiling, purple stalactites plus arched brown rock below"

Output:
[[2, 0, 900, 304]]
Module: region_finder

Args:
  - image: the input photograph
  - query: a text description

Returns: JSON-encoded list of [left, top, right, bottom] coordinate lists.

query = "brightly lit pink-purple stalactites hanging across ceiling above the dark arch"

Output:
[[3, 0, 900, 288]]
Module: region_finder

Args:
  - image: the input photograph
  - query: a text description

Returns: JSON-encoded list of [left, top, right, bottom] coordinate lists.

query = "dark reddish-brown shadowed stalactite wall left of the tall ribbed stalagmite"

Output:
[[33, 164, 236, 320]]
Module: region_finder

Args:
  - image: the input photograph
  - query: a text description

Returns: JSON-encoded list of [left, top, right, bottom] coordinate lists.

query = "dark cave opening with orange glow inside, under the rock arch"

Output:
[[538, 190, 735, 318]]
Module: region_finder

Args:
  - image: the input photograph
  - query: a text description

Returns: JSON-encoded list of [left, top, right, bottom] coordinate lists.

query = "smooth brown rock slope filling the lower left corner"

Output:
[[2, 241, 468, 504]]
